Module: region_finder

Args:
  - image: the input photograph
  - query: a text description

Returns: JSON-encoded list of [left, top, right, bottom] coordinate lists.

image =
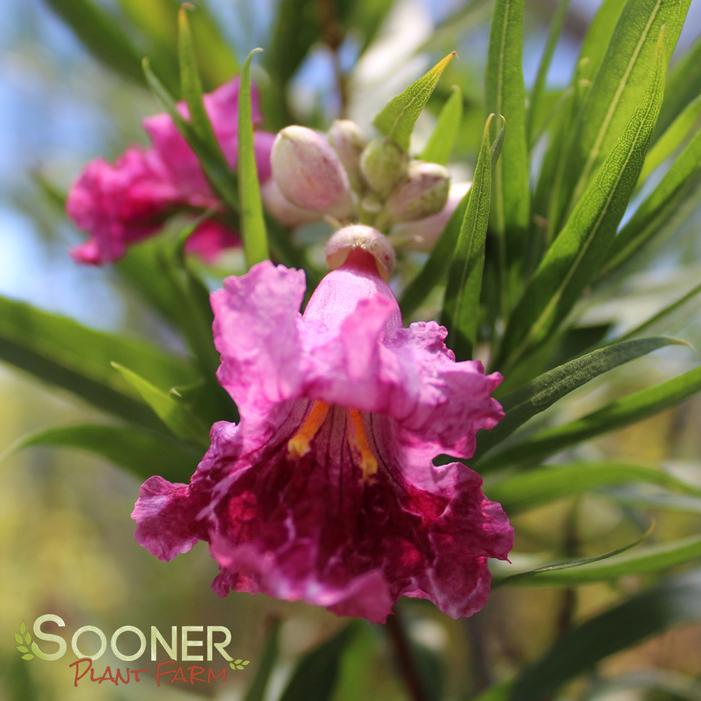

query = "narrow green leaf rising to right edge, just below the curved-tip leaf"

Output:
[[479, 360, 701, 471]]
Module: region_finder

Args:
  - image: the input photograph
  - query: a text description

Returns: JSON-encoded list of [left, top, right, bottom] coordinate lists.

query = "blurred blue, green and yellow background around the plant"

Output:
[[0, 0, 701, 701]]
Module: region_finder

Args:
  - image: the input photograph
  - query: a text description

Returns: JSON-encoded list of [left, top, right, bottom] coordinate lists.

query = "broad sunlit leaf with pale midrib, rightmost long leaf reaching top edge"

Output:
[[565, 0, 690, 216]]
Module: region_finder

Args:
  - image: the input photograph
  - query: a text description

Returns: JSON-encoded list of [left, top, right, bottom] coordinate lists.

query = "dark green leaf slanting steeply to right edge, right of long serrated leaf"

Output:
[[602, 123, 701, 275]]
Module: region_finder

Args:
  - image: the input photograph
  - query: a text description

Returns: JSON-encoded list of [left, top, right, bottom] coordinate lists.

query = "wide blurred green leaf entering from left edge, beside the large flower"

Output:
[[0, 297, 197, 427]]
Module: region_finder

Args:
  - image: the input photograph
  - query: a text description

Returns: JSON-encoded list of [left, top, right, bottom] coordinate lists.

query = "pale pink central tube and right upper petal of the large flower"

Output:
[[302, 266, 503, 456]]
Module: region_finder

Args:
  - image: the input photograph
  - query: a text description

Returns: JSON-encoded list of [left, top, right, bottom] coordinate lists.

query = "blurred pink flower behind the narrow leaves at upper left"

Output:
[[67, 78, 275, 265]]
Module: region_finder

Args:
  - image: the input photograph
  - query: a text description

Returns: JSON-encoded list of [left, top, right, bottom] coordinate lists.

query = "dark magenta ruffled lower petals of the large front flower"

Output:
[[141, 409, 513, 622]]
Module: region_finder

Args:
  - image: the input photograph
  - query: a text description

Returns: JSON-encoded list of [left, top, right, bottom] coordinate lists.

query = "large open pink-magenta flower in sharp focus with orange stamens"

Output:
[[132, 227, 513, 622]]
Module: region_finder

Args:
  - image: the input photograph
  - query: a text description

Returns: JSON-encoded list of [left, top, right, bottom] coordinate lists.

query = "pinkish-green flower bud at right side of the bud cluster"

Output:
[[385, 161, 450, 222]]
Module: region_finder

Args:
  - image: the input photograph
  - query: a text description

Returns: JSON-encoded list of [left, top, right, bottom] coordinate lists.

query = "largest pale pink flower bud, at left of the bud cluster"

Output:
[[270, 126, 353, 219]]
